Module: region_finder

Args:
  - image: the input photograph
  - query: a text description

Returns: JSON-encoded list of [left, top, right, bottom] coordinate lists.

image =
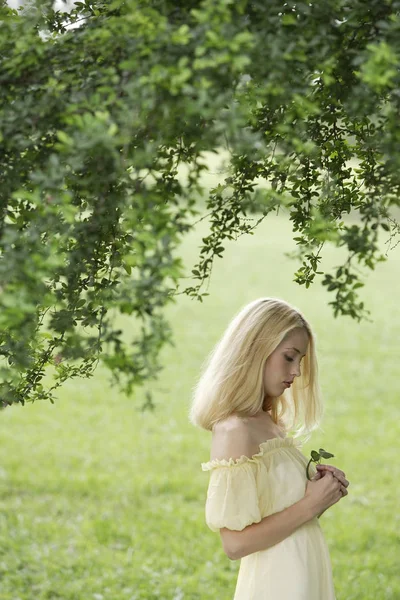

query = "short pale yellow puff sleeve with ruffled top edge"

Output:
[[202, 457, 261, 531]]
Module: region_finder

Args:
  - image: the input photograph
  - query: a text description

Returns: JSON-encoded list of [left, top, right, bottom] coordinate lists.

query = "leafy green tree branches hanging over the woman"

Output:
[[0, 0, 400, 404]]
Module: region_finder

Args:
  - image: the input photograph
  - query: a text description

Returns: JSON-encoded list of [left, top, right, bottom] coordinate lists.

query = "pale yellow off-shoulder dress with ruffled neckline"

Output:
[[201, 437, 335, 600]]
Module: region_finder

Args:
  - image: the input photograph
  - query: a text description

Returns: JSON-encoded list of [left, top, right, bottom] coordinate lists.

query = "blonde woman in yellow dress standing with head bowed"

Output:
[[190, 298, 349, 600]]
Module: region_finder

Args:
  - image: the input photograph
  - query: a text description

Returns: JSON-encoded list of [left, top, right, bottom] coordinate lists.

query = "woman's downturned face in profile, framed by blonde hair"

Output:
[[263, 327, 309, 398]]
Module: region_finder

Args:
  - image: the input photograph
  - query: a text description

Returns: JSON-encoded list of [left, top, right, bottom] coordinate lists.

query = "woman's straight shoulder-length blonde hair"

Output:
[[189, 298, 323, 439]]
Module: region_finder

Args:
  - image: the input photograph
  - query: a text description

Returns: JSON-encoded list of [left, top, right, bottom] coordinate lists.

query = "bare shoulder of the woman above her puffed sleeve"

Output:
[[211, 415, 256, 460]]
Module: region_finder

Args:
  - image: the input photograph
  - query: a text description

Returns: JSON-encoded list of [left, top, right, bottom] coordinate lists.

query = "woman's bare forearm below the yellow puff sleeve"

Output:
[[223, 498, 316, 560]]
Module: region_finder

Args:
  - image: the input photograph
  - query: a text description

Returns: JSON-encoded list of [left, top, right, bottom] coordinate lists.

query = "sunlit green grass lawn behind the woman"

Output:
[[0, 207, 400, 600]]
